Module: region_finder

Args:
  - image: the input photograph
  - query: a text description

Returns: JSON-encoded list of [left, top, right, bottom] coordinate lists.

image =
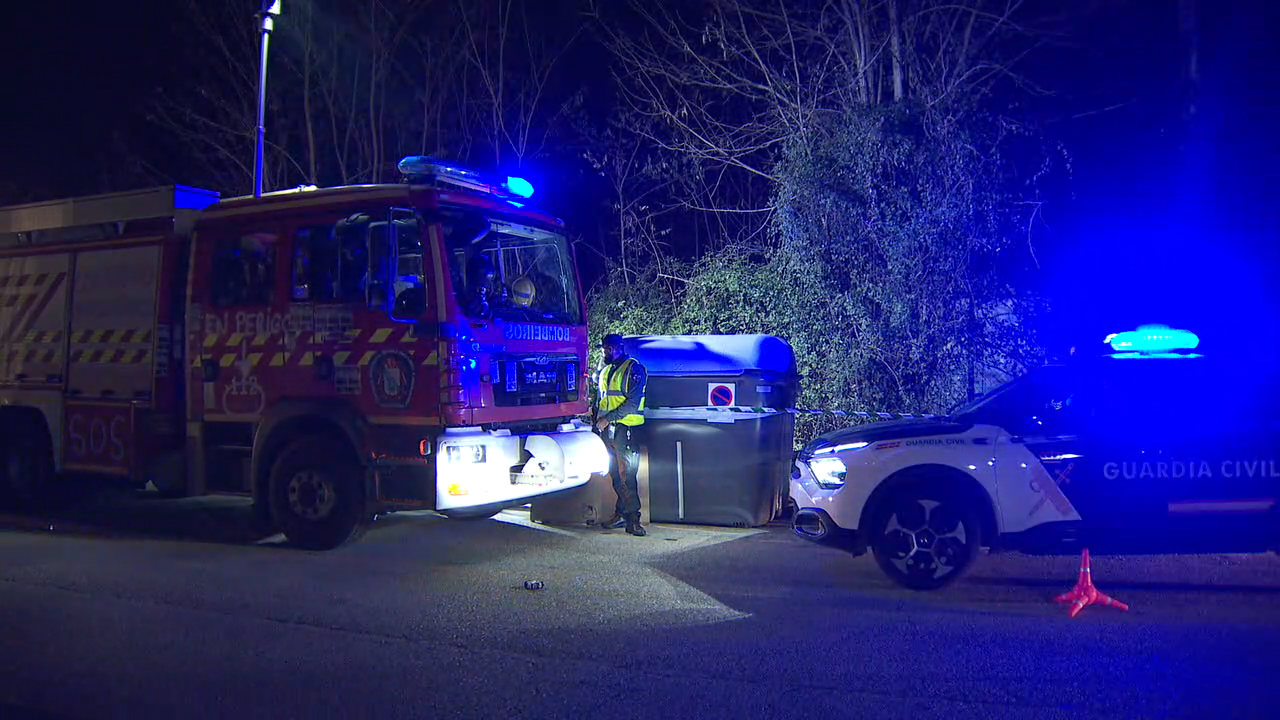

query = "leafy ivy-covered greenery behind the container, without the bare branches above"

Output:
[[591, 105, 1041, 434]]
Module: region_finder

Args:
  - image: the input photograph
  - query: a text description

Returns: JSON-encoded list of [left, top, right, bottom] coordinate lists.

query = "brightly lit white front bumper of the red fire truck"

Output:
[[435, 420, 609, 510]]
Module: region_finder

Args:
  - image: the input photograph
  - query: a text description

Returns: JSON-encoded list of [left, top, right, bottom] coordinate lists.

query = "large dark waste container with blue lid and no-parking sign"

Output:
[[625, 334, 797, 527]]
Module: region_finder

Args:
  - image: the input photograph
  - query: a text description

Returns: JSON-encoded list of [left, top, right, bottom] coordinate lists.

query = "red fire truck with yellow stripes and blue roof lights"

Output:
[[0, 158, 609, 550]]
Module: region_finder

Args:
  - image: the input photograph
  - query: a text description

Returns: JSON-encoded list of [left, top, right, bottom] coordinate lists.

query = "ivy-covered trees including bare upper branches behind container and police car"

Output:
[[591, 0, 1069, 439]]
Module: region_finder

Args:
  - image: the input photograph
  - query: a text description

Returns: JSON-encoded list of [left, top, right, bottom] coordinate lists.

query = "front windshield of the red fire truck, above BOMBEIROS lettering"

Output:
[[443, 204, 582, 325]]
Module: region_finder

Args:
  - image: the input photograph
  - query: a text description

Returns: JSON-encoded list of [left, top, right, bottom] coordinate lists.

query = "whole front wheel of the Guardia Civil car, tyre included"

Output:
[[868, 484, 982, 591]]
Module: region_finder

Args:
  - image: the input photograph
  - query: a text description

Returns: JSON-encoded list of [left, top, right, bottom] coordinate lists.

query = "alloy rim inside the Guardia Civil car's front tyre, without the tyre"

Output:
[[881, 498, 970, 580]]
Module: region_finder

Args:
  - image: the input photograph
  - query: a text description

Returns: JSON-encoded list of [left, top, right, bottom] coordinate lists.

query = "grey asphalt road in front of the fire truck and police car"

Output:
[[0, 486, 1280, 720]]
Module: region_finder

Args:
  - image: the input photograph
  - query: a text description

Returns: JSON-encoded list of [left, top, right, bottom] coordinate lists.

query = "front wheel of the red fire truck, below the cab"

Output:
[[269, 430, 369, 550]]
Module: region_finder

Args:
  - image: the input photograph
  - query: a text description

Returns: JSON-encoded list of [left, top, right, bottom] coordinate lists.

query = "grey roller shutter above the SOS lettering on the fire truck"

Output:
[[67, 245, 160, 401]]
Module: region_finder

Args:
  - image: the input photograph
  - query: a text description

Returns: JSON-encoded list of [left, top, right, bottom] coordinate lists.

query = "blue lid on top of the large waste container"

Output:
[[623, 334, 796, 375]]
